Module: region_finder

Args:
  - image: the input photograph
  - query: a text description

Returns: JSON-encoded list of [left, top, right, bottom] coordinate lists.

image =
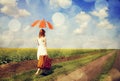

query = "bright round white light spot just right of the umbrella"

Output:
[[52, 12, 65, 26]]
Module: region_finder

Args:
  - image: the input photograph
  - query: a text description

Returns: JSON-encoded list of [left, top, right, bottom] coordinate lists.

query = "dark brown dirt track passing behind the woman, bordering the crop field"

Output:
[[0, 52, 93, 78]]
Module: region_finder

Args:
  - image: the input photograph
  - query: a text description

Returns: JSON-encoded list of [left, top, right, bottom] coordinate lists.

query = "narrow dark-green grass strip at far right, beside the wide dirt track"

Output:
[[94, 52, 117, 81]]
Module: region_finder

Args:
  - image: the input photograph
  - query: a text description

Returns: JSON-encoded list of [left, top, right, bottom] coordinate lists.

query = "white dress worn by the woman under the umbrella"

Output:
[[37, 37, 47, 60]]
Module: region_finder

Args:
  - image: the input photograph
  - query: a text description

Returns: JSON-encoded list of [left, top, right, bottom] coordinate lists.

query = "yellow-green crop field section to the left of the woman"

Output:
[[0, 48, 36, 64]]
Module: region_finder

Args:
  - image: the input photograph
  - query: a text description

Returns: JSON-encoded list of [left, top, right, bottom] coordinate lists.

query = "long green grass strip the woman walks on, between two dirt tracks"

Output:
[[1, 52, 111, 81]]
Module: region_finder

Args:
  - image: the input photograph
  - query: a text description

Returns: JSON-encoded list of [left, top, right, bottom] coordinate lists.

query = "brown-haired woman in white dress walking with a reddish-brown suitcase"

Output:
[[35, 29, 50, 75]]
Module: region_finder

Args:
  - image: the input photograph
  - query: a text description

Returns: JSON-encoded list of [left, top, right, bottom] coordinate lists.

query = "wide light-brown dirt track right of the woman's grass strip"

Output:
[[56, 51, 115, 81]]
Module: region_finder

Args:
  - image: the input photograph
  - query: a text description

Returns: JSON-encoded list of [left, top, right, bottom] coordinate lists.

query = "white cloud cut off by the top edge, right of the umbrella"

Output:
[[50, 0, 72, 9]]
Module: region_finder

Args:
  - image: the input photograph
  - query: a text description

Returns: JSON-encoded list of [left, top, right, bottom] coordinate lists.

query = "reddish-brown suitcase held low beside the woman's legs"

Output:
[[37, 55, 52, 69]]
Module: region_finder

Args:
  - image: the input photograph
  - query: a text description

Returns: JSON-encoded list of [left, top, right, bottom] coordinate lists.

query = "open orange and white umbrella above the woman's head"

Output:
[[31, 19, 53, 29]]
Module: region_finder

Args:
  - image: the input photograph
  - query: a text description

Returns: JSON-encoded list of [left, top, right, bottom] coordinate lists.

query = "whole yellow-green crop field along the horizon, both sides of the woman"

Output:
[[0, 48, 104, 65]]
